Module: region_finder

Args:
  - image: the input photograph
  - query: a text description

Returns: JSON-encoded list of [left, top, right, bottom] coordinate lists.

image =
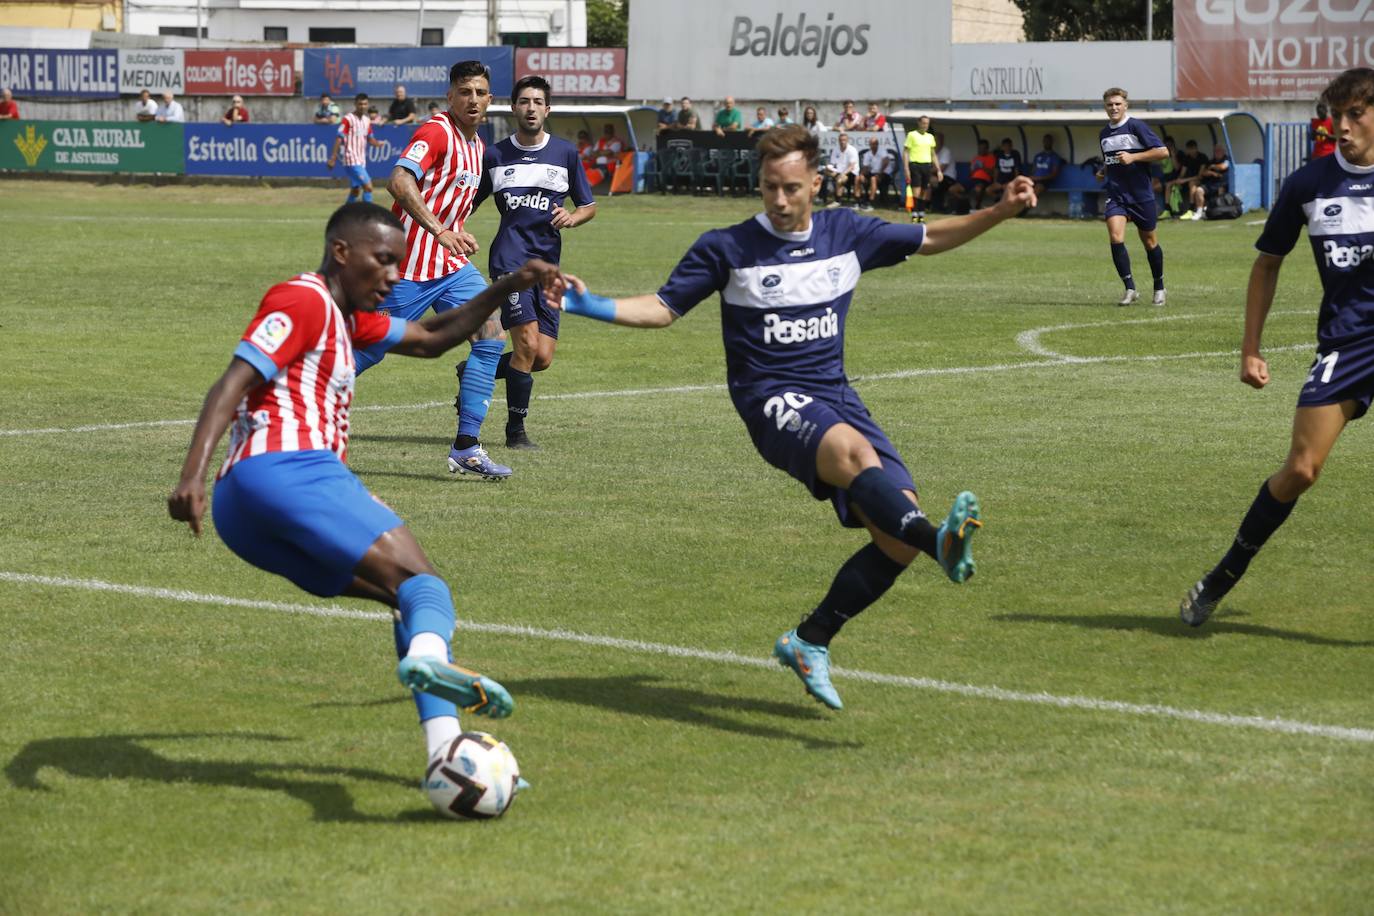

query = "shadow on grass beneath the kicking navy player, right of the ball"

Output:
[[506, 674, 863, 750]]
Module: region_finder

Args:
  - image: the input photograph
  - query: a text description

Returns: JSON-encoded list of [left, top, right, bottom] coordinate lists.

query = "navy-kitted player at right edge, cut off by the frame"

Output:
[[1179, 67, 1374, 626]]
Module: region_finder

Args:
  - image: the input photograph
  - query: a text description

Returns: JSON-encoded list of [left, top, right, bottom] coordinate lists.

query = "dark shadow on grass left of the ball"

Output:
[[4, 732, 415, 823]]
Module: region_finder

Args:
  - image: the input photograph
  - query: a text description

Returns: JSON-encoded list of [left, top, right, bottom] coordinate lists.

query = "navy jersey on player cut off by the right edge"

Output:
[[1254, 150, 1374, 353]]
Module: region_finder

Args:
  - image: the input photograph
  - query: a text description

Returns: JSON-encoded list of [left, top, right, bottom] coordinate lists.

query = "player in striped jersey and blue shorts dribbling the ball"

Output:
[[168, 203, 561, 751]]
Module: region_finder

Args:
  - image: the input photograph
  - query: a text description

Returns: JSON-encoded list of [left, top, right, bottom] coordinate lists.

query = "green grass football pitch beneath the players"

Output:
[[0, 181, 1374, 913]]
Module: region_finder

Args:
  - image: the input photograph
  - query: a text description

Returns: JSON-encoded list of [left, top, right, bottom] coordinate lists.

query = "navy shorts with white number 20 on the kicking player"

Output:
[[730, 383, 916, 527]]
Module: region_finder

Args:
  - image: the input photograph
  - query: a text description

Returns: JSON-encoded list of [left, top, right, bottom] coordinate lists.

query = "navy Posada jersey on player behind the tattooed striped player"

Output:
[[474, 136, 594, 276]]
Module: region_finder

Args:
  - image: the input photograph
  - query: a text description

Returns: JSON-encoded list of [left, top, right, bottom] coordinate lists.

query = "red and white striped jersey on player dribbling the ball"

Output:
[[216, 273, 404, 479]]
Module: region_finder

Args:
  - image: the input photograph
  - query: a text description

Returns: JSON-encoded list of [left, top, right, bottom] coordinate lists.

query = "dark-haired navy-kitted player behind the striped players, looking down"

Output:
[[472, 76, 596, 449]]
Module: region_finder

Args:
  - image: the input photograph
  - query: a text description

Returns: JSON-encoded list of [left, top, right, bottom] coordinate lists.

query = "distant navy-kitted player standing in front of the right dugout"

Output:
[[1098, 87, 1169, 305]]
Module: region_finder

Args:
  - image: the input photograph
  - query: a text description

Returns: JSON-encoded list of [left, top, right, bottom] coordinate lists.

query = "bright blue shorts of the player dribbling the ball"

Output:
[[212, 449, 404, 597]]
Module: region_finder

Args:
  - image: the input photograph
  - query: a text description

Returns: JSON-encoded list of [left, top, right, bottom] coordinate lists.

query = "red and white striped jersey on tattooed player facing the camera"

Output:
[[392, 111, 486, 280]]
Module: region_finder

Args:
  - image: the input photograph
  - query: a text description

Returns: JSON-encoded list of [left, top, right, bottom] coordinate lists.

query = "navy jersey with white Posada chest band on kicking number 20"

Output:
[[658, 210, 926, 386]]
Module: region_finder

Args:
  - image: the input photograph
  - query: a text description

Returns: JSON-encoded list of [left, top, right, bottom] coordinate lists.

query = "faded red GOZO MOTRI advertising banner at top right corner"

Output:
[[1173, 0, 1374, 100]]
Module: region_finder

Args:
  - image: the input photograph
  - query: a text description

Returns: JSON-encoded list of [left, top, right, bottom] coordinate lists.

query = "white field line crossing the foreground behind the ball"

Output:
[[0, 571, 1374, 744]]
